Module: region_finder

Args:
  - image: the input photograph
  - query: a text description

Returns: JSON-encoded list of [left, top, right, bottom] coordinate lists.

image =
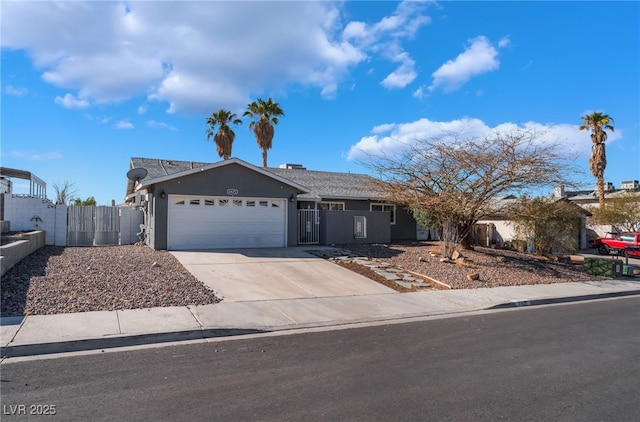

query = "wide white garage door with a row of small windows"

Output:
[[167, 195, 287, 250]]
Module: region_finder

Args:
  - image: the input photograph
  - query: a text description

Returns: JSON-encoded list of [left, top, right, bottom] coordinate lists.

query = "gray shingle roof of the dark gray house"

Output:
[[127, 157, 384, 200]]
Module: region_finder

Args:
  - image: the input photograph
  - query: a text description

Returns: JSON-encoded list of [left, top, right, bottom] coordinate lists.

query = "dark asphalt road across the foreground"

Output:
[[0, 298, 640, 421]]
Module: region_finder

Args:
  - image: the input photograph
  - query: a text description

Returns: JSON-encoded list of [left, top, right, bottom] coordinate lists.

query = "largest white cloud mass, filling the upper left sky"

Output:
[[1, 1, 429, 112]]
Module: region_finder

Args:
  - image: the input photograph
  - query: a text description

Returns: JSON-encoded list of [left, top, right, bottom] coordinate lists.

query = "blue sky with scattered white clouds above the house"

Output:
[[0, 1, 640, 205]]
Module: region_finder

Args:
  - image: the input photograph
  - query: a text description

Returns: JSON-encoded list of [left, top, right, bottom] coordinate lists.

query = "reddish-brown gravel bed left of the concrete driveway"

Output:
[[0, 245, 219, 316]]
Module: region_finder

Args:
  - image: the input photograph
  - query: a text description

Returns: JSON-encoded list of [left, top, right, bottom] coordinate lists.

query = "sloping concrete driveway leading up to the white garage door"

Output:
[[171, 247, 395, 302]]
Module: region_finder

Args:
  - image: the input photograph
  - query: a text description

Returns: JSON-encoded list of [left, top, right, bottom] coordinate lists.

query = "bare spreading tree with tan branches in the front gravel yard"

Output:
[[364, 131, 573, 255]]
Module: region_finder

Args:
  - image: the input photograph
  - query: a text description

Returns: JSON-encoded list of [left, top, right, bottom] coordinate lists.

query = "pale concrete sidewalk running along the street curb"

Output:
[[0, 279, 640, 358]]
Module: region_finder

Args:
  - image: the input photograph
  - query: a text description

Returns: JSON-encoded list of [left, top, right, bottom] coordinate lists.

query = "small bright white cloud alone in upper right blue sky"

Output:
[[429, 36, 508, 92]]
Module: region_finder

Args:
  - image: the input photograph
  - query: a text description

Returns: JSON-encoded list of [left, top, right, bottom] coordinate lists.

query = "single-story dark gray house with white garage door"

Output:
[[125, 158, 417, 250]]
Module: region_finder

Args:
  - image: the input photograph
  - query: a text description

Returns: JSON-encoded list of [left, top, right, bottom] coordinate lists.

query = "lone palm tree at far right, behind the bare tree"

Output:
[[580, 112, 613, 209]]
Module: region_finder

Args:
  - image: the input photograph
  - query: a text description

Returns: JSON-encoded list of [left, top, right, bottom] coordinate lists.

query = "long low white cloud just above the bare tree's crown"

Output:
[[347, 117, 623, 161]]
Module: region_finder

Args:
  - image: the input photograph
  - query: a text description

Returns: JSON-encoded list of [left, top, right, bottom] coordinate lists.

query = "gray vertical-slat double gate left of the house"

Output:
[[67, 205, 120, 246]]
